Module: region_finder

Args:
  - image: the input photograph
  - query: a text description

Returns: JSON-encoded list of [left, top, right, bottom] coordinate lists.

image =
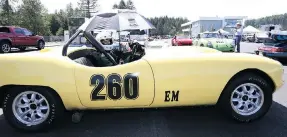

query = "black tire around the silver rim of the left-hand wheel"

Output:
[[3, 87, 65, 132]]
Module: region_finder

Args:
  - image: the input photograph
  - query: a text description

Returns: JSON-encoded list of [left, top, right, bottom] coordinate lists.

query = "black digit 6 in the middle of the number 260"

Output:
[[106, 74, 122, 100]]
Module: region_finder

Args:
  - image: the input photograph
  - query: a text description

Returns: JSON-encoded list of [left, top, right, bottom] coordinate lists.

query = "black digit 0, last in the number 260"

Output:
[[124, 74, 139, 100]]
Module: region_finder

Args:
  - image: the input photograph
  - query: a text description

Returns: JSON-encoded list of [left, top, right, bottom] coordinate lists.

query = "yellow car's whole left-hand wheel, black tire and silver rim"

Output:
[[3, 87, 64, 132]]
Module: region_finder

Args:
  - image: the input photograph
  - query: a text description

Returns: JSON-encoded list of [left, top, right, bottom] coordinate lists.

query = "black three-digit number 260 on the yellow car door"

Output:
[[90, 73, 139, 101]]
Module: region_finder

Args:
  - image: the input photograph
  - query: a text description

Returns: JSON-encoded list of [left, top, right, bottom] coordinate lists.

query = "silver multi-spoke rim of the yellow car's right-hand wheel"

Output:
[[230, 83, 264, 116]]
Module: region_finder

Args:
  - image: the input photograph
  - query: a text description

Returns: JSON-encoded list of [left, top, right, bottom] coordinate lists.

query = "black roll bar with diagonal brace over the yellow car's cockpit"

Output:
[[62, 31, 118, 66]]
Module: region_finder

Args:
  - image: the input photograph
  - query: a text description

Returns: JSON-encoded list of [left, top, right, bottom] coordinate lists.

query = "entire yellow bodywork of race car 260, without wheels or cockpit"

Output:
[[0, 47, 283, 109]]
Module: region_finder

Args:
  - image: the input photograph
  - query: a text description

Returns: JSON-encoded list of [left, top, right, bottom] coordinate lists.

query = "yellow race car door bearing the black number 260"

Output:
[[75, 59, 154, 108]]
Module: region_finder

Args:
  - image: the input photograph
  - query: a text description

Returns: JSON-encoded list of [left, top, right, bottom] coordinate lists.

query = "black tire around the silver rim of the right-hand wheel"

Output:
[[217, 73, 273, 123]]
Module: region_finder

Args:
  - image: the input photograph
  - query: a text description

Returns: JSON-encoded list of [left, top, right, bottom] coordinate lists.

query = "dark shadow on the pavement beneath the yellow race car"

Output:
[[0, 102, 287, 137]]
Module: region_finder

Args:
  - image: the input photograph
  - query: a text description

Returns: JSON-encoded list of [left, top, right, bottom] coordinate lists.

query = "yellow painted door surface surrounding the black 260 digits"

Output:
[[75, 60, 154, 108]]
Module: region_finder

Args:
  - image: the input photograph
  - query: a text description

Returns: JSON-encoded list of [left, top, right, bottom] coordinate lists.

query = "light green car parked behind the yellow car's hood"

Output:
[[194, 32, 235, 52]]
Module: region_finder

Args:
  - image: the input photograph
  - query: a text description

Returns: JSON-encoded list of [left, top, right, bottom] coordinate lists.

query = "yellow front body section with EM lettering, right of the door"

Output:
[[144, 47, 283, 106]]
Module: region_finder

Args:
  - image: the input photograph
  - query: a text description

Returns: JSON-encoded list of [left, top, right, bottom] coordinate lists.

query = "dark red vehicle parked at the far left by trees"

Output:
[[0, 26, 45, 53]]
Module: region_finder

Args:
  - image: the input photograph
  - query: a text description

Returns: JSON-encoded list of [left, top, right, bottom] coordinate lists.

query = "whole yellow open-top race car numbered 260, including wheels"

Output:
[[0, 29, 283, 131]]
